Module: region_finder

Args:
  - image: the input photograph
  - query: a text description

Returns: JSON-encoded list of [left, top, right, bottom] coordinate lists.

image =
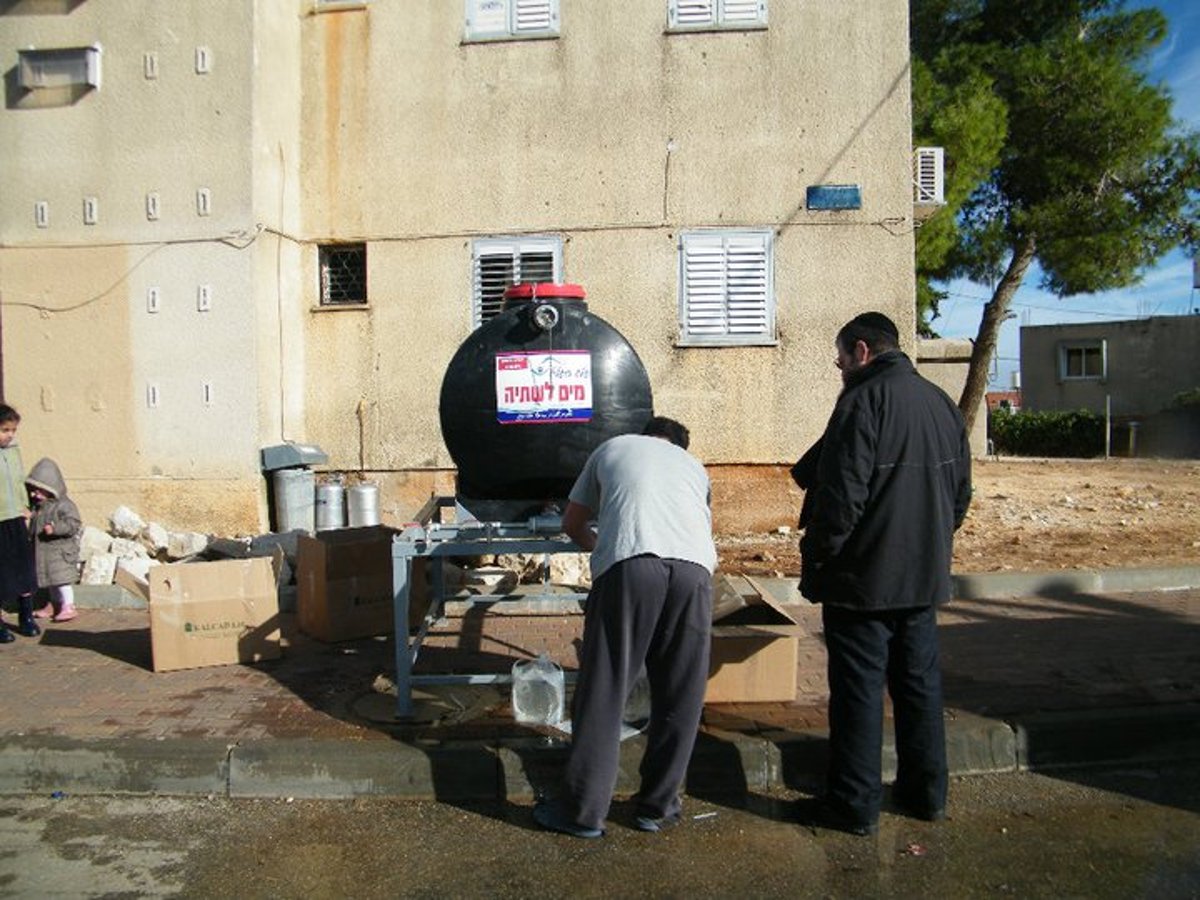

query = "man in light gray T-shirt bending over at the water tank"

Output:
[[534, 416, 716, 838]]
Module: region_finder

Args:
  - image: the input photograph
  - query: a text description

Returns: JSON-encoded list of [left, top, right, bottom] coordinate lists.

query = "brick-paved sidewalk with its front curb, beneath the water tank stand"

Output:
[[0, 569, 1200, 798]]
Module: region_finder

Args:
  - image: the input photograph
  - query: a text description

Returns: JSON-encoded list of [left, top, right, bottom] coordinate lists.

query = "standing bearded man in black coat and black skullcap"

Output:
[[799, 312, 971, 835]]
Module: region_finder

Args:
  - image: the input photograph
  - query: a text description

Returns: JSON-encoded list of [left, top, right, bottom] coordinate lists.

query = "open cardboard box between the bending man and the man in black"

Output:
[[704, 575, 804, 703]]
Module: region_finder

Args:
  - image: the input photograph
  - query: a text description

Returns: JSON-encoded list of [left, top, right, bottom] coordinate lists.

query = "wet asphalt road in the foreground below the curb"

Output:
[[0, 762, 1200, 899]]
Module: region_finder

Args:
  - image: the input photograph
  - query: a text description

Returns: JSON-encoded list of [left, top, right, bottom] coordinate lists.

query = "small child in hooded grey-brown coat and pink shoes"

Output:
[[25, 458, 83, 622]]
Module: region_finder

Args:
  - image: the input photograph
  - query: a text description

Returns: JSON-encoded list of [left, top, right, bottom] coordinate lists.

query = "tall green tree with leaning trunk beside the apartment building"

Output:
[[912, 0, 1200, 427]]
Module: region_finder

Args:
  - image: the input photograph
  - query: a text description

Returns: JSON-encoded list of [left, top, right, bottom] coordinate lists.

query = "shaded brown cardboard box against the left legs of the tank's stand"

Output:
[[296, 526, 425, 642]]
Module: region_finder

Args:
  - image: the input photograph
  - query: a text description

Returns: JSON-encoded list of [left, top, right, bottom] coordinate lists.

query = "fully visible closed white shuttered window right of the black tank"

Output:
[[679, 230, 775, 344]]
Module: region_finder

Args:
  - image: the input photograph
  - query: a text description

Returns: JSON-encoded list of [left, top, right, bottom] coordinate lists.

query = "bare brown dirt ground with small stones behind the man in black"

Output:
[[718, 457, 1200, 576]]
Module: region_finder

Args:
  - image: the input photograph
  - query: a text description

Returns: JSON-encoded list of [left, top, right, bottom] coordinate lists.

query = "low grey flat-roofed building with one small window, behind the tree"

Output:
[[1021, 316, 1200, 456]]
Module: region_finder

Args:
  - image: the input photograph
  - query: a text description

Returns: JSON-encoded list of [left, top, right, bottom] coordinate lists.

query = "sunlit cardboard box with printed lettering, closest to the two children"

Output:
[[149, 557, 281, 672]]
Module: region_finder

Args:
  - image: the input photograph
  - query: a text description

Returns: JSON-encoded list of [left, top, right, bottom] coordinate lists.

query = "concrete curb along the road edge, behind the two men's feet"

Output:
[[0, 703, 1200, 800]]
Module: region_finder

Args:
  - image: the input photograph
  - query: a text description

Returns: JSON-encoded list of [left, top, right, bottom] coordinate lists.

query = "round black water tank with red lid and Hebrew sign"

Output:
[[439, 284, 654, 517]]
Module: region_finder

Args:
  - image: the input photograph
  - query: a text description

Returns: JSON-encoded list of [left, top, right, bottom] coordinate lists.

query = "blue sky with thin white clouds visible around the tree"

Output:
[[932, 0, 1200, 390]]
